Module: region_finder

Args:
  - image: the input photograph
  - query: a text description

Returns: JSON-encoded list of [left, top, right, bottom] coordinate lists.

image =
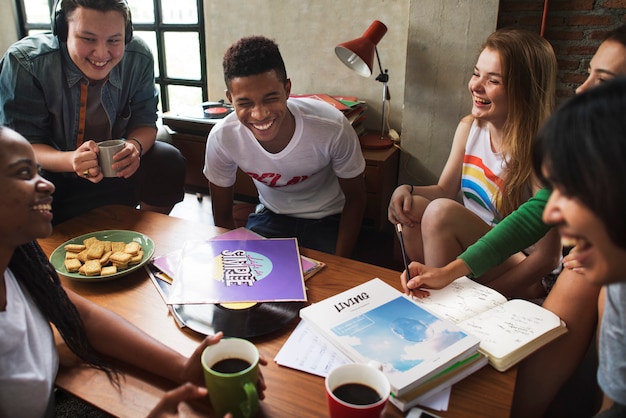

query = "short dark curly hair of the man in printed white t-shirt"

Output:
[[222, 36, 287, 88]]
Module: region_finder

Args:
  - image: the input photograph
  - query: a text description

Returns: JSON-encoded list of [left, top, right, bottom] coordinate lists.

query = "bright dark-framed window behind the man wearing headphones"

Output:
[[16, 0, 209, 112]]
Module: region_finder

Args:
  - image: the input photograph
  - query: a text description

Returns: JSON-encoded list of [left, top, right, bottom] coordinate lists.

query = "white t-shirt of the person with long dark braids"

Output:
[[0, 269, 59, 417]]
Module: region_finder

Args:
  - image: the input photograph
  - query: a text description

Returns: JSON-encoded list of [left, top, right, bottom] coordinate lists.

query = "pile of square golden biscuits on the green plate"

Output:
[[65, 237, 143, 276]]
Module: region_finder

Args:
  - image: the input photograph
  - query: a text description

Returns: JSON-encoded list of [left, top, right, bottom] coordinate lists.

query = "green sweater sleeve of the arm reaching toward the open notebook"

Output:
[[458, 188, 551, 277]]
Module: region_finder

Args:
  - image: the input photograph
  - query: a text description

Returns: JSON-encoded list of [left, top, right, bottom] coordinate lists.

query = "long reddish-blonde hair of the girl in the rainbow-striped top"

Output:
[[481, 29, 558, 217]]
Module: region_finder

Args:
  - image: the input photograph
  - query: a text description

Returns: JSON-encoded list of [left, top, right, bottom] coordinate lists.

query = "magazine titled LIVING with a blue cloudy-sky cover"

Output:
[[300, 279, 479, 396]]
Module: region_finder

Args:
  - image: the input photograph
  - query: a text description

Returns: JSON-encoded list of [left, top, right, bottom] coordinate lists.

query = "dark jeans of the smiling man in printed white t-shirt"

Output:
[[246, 207, 340, 254]]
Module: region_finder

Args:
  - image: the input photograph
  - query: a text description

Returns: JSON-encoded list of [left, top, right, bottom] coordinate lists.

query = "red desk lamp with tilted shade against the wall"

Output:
[[335, 20, 393, 149]]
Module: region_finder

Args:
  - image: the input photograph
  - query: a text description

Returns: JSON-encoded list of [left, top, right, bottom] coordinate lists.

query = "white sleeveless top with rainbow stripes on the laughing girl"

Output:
[[461, 121, 506, 226]]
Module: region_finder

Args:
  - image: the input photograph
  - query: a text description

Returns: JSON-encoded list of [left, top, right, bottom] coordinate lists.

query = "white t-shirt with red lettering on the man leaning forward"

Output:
[[204, 98, 365, 219]]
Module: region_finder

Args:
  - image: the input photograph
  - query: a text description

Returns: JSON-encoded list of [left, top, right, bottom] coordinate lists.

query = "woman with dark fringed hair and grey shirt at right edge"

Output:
[[519, 77, 626, 418]]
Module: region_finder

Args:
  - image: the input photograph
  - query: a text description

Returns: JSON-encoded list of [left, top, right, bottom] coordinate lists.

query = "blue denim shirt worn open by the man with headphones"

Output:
[[0, 34, 158, 151]]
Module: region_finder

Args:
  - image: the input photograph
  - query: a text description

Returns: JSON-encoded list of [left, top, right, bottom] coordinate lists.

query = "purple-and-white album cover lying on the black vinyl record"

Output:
[[167, 238, 306, 304]]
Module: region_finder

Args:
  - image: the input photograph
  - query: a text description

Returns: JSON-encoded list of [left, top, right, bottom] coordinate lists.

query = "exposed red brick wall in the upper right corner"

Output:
[[498, 0, 626, 101]]
